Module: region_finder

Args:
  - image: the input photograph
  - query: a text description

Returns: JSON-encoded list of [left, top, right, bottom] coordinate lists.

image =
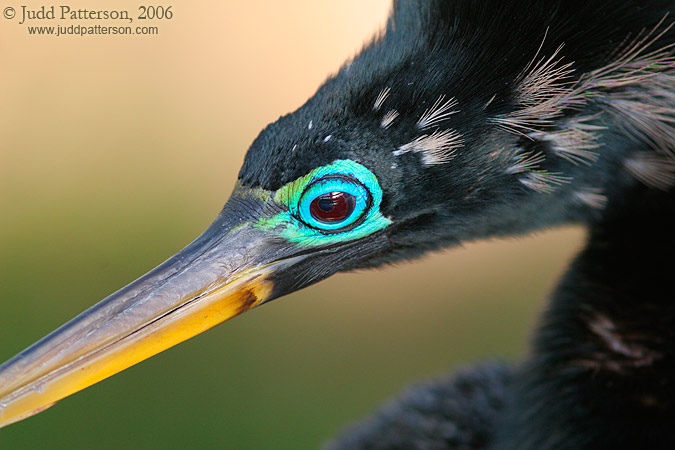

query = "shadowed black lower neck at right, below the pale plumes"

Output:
[[497, 185, 675, 450]]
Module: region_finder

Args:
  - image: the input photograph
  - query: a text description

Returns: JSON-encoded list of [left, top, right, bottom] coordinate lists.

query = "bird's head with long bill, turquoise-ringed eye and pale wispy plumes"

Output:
[[0, 1, 675, 425]]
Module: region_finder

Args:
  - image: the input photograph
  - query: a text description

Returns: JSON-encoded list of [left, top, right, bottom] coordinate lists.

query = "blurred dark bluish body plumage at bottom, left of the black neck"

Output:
[[326, 364, 511, 450]]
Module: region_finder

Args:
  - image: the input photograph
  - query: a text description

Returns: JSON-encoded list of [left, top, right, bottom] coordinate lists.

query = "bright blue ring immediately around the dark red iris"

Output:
[[297, 174, 373, 234]]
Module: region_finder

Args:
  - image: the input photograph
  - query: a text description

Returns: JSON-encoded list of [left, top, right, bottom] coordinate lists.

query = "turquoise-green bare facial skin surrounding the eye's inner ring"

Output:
[[254, 160, 391, 247]]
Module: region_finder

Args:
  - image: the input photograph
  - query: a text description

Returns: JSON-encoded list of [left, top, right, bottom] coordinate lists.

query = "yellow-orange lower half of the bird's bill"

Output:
[[0, 269, 273, 427]]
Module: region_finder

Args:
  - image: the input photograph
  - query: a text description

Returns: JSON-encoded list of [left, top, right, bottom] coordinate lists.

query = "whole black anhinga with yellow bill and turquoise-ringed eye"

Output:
[[0, 0, 675, 450]]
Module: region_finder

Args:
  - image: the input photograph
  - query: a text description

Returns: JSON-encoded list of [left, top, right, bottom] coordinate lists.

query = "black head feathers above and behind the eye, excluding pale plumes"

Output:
[[239, 1, 673, 265]]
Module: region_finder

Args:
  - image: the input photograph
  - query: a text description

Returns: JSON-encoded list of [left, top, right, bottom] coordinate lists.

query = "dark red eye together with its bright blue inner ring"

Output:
[[298, 176, 372, 231]]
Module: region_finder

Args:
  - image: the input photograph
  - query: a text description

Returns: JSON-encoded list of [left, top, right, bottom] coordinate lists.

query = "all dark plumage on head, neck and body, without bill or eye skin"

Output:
[[240, 0, 675, 450]]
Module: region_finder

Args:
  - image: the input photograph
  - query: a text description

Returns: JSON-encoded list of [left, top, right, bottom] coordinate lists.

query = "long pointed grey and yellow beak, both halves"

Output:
[[0, 191, 305, 427]]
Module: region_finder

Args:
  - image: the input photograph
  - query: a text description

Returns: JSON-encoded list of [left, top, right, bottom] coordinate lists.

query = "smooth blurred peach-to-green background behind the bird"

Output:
[[0, 0, 583, 450]]
